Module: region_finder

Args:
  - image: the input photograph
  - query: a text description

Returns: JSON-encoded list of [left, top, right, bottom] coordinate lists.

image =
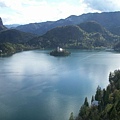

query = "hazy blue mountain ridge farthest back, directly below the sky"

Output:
[[16, 12, 120, 35]]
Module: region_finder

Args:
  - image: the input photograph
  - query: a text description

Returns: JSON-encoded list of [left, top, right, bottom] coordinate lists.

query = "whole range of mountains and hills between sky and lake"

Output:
[[0, 12, 120, 52]]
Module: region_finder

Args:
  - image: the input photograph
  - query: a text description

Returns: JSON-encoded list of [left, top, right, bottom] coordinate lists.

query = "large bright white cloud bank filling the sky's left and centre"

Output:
[[0, 0, 89, 24]]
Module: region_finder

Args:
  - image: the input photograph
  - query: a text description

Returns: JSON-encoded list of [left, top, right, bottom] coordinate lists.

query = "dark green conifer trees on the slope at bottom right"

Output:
[[76, 70, 120, 120]]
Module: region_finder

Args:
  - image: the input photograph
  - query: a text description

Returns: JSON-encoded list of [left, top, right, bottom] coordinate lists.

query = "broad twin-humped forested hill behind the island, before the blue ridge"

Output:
[[28, 22, 120, 49]]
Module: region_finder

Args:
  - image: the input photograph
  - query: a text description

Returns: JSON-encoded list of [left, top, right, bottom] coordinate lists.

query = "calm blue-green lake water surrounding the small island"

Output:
[[0, 50, 120, 120]]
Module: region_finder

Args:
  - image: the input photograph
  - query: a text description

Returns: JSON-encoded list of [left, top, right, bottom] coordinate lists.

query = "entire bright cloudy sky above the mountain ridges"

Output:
[[0, 0, 120, 25]]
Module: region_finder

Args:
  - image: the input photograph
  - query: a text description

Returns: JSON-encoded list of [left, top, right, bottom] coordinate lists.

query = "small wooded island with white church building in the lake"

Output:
[[50, 47, 71, 56]]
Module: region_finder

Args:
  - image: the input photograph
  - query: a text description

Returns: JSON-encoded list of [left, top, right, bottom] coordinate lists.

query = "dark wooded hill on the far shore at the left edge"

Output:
[[0, 29, 35, 56]]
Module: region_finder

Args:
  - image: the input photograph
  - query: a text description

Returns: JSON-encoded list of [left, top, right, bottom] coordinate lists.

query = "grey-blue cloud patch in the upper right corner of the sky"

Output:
[[84, 0, 120, 12]]
